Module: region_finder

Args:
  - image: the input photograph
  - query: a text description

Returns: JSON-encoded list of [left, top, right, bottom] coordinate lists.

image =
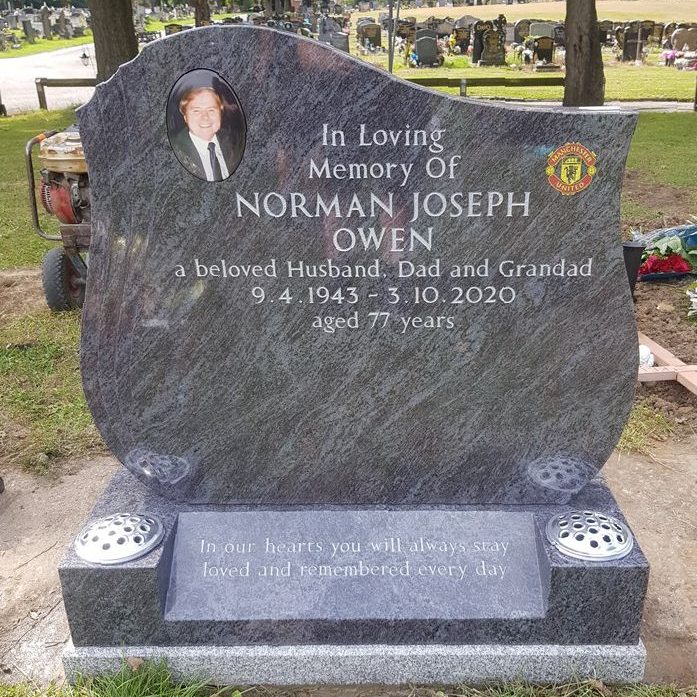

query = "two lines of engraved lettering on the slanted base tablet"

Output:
[[198, 536, 511, 582]]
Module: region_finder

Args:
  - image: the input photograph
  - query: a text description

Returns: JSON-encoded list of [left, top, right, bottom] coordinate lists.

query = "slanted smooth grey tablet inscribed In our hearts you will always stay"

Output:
[[165, 511, 547, 621]]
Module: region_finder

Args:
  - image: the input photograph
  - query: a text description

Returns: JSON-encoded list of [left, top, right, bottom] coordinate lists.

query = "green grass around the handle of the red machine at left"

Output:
[[0, 109, 75, 269]]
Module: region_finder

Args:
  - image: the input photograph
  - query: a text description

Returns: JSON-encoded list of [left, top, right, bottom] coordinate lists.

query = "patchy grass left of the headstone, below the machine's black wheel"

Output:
[[0, 310, 101, 470]]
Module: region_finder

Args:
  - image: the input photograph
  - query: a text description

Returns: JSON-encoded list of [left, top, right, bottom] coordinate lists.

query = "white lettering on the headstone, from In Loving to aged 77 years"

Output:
[[174, 123, 594, 334]]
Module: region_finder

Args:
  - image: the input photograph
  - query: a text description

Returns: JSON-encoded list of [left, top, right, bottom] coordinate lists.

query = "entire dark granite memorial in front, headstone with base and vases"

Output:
[[60, 26, 648, 684]]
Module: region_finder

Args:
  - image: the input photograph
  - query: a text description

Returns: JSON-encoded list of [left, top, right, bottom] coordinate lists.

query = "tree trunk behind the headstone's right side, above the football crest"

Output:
[[564, 0, 605, 106]]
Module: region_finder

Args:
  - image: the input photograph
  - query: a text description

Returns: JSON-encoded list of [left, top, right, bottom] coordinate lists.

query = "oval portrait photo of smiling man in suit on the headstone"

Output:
[[167, 70, 246, 182]]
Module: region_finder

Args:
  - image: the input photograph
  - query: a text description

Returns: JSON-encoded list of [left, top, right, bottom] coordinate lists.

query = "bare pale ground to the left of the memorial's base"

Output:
[[0, 457, 118, 683]]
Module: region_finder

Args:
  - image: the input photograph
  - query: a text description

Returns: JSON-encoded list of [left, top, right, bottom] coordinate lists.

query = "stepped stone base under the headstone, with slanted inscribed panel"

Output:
[[59, 470, 649, 685]]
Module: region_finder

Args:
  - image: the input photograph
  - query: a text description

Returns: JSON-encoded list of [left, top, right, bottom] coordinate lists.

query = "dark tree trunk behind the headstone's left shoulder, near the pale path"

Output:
[[87, 0, 138, 82]]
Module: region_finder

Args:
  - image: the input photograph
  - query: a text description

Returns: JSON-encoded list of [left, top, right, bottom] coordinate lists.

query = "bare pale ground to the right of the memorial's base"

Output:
[[602, 436, 697, 685]]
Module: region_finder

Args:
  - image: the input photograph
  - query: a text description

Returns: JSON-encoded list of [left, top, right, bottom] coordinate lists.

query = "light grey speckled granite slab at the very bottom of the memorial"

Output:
[[63, 642, 646, 685]]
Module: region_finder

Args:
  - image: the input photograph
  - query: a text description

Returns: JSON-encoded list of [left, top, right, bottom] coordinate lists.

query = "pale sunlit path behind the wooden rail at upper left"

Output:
[[0, 44, 97, 114]]
